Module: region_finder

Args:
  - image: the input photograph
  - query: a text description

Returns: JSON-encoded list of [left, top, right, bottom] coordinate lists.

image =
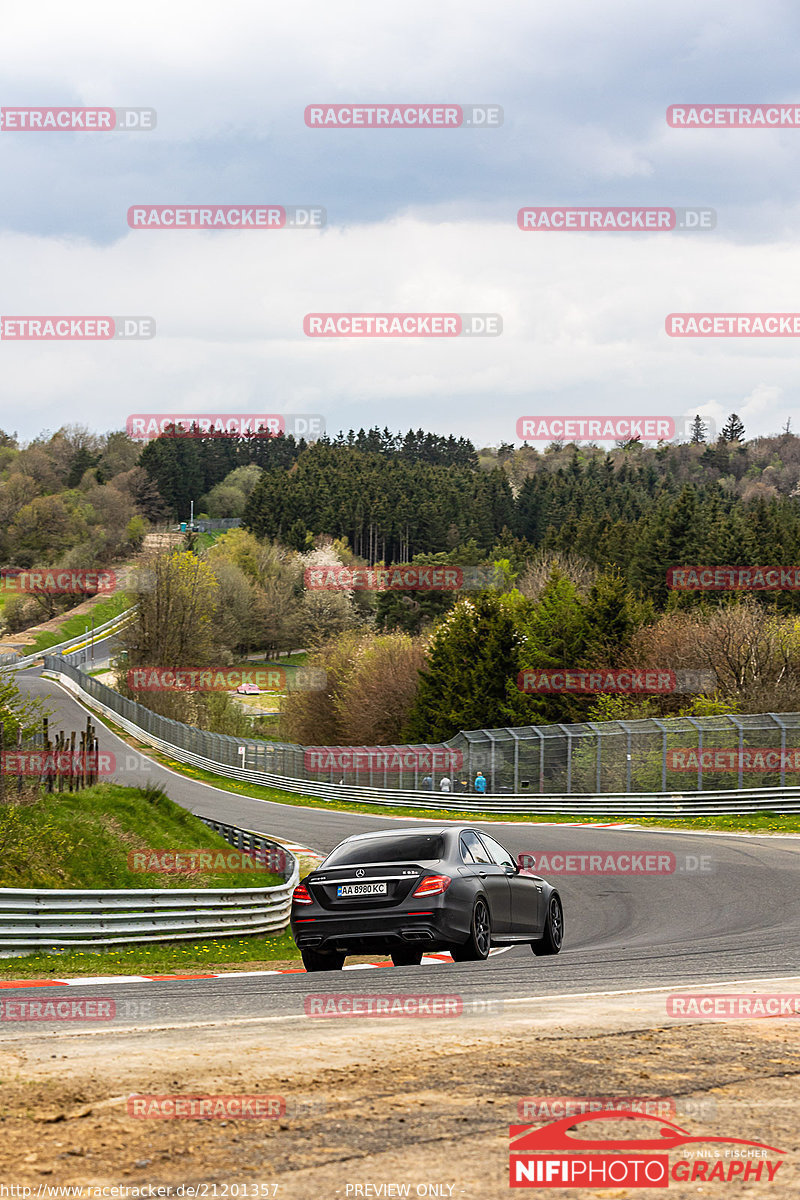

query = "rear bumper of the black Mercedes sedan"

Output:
[[291, 910, 470, 954]]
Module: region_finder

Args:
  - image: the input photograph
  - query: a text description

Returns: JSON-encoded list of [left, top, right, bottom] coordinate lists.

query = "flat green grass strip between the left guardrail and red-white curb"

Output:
[[0, 930, 301, 979]]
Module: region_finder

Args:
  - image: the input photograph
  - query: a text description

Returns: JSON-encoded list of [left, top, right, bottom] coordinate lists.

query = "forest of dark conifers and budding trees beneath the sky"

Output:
[[7, 418, 800, 743]]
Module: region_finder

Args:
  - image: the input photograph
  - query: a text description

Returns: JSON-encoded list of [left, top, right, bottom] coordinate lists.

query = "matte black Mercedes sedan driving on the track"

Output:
[[291, 827, 564, 971]]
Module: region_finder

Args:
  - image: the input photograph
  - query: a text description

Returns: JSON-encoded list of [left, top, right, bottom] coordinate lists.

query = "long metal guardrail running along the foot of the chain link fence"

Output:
[[44, 659, 800, 818]]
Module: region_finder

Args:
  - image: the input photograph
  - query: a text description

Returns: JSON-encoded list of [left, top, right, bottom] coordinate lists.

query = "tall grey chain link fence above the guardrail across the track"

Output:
[[44, 655, 800, 797]]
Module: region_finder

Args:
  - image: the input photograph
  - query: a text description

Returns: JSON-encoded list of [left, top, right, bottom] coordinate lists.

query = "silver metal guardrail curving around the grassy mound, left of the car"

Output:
[[0, 817, 300, 950]]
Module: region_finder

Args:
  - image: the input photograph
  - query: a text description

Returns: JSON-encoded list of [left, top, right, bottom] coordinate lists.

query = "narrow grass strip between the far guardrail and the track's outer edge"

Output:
[[81, 720, 800, 848]]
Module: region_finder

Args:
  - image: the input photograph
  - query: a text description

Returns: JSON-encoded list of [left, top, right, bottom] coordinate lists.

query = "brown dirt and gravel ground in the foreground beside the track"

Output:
[[0, 994, 800, 1200]]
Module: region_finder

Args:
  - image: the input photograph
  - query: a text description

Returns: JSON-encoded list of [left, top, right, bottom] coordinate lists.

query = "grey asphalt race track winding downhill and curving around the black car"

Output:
[[4, 672, 800, 1028]]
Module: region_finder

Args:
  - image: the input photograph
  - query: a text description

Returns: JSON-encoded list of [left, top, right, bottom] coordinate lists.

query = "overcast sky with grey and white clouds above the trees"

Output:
[[0, 0, 800, 444]]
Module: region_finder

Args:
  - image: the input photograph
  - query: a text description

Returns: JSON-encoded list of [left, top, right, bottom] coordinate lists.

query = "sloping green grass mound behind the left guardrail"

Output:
[[0, 784, 282, 888]]
